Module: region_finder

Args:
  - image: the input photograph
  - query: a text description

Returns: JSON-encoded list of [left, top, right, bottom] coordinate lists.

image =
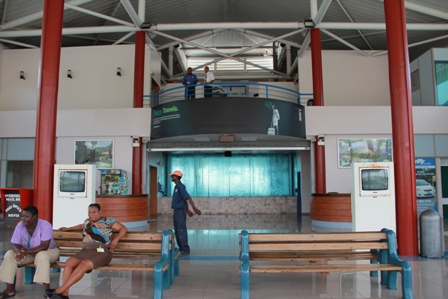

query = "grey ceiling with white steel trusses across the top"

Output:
[[0, 0, 448, 77]]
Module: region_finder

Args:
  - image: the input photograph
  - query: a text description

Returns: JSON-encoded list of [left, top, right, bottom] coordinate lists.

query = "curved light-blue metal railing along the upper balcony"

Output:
[[144, 82, 313, 107]]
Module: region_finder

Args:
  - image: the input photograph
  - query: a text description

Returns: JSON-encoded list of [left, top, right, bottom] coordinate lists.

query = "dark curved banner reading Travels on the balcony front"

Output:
[[151, 97, 306, 140]]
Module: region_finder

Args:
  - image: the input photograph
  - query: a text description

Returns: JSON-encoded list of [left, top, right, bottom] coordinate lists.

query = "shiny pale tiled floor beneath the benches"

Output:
[[0, 214, 448, 299]]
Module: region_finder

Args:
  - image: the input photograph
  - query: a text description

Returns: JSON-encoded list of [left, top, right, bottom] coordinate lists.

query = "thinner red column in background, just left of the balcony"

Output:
[[132, 31, 145, 194]]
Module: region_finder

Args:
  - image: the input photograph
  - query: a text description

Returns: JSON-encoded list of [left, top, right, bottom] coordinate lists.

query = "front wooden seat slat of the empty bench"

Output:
[[250, 264, 402, 273]]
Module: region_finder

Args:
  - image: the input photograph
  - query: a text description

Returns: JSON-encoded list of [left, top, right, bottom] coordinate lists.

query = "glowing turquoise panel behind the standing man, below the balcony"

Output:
[[167, 153, 294, 197]]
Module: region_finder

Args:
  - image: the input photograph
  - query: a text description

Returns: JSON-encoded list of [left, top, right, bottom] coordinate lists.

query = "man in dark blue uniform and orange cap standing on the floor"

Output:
[[170, 170, 201, 256]]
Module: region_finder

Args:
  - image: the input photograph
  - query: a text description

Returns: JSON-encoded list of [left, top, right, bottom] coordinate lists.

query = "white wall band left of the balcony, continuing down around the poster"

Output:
[[0, 108, 151, 193]]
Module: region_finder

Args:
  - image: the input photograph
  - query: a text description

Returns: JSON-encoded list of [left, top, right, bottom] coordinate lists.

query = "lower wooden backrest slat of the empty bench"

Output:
[[249, 242, 388, 252]]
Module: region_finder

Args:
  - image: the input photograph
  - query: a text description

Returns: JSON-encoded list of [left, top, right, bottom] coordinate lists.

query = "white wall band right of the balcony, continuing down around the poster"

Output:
[[305, 106, 448, 193]]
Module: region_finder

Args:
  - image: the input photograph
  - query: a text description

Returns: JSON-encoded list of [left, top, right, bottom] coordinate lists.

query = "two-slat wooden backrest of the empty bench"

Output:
[[240, 231, 389, 252]]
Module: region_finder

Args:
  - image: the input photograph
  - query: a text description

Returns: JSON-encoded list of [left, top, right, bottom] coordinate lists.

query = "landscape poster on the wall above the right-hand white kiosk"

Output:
[[338, 138, 392, 168]]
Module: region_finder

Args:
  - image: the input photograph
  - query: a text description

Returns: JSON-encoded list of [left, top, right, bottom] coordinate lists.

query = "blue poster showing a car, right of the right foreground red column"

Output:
[[415, 158, 437, 215]]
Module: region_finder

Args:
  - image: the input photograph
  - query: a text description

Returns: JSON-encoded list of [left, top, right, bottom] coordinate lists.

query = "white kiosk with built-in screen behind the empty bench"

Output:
[[352, 162, 396, 232]]
